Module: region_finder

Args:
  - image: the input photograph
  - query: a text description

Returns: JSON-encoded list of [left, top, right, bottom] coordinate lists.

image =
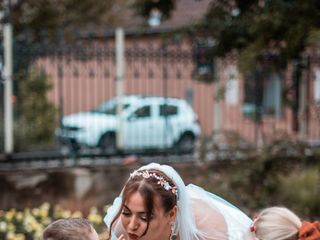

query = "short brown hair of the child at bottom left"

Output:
[[41, 218, 93, 240]]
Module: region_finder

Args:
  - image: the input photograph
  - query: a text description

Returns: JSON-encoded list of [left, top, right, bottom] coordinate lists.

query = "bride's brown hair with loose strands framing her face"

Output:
[[109, 169, 177, 236]]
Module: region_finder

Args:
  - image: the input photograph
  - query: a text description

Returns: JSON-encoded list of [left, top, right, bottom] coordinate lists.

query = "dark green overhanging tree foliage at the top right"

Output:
[[135, 0, 320, 74]]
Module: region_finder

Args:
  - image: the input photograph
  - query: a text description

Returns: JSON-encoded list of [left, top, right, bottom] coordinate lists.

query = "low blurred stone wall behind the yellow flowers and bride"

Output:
[[0, 163, 220, 211]]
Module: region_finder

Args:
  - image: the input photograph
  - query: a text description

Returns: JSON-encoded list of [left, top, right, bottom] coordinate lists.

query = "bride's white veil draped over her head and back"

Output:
[[104, 163, 251, 240]]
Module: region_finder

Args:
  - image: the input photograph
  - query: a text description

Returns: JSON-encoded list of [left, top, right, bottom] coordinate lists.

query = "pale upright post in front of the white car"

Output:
[[116, 28, 124, 149]]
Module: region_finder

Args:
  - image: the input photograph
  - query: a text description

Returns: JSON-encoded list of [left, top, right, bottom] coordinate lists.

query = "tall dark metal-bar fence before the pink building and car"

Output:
[[0, 37, 320, 156]]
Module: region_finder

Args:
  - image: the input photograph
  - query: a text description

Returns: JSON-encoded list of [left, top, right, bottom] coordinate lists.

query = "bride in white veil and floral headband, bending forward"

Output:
[[104, 163, 252, 240]]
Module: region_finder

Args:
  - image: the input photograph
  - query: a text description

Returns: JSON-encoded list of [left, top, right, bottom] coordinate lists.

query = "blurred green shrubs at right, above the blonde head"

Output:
[[201, 131, 320, 218]]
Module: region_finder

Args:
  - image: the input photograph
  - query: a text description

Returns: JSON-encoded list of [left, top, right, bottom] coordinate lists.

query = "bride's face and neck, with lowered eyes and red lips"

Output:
[[121, 192, 176, 240]]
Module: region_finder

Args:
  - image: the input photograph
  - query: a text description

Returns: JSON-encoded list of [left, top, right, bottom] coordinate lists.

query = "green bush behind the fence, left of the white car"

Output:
[[15, 70, 57, 150]]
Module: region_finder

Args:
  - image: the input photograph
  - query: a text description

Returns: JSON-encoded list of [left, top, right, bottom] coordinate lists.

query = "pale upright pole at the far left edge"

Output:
[[3, 0, 13, 154]]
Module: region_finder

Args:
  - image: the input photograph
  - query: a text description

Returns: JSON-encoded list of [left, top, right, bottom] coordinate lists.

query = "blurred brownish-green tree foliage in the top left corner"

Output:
[[0, 0, 127, 42]]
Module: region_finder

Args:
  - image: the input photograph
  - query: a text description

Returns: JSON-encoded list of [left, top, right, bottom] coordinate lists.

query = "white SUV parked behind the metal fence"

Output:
[[56, 95, 200, 153]]
